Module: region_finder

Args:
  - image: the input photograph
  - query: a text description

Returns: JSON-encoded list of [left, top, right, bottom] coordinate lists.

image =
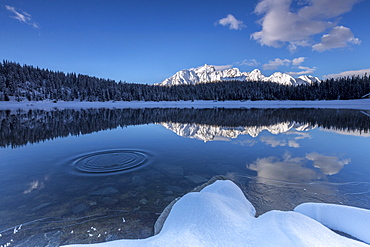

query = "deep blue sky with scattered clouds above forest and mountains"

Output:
[[0, 0, 370, 84]]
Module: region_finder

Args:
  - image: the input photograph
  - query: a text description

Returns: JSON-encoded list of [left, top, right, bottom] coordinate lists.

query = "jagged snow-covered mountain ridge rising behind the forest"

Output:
[[157, 64, 320, 86]]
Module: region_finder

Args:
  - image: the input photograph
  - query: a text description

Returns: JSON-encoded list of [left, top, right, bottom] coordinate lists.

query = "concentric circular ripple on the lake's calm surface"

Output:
[[74, 150, 147, 174]]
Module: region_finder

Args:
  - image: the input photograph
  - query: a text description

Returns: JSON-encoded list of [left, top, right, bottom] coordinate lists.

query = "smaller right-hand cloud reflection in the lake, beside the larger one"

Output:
[[306, 152, 351, 175]]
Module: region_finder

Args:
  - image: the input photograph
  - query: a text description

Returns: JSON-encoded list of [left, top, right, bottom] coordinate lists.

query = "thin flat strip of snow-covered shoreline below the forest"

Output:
[[0, 99, 370, 110]]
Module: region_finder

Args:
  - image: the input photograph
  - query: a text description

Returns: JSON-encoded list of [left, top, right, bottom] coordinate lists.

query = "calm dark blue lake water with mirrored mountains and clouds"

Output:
[[0, 109, 370, 246]]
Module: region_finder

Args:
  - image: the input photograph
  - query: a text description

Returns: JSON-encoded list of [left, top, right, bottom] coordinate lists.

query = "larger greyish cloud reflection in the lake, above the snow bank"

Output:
[[247, 154, 317, 182]]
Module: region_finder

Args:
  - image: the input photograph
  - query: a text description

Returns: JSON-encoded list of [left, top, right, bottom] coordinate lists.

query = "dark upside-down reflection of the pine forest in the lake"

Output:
[[0, 108, 370, 147]]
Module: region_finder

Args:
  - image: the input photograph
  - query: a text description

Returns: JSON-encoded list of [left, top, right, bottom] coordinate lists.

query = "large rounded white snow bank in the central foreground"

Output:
[[62, 180, 369, 247]]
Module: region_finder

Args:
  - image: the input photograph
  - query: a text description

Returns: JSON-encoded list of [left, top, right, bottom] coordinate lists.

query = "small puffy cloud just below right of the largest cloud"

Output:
[[312, 26, 361, 52]]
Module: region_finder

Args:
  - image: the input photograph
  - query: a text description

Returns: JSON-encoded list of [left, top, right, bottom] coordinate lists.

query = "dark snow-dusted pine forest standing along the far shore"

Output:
[[0, 61, 370, 101]]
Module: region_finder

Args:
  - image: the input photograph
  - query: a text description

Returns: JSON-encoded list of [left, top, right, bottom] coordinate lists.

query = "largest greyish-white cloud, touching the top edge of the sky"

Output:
[[251, 0, 360, 51]]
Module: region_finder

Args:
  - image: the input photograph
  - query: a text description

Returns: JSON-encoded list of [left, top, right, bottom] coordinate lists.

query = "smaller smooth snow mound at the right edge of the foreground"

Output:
[[294, 203, 370, 243]]
